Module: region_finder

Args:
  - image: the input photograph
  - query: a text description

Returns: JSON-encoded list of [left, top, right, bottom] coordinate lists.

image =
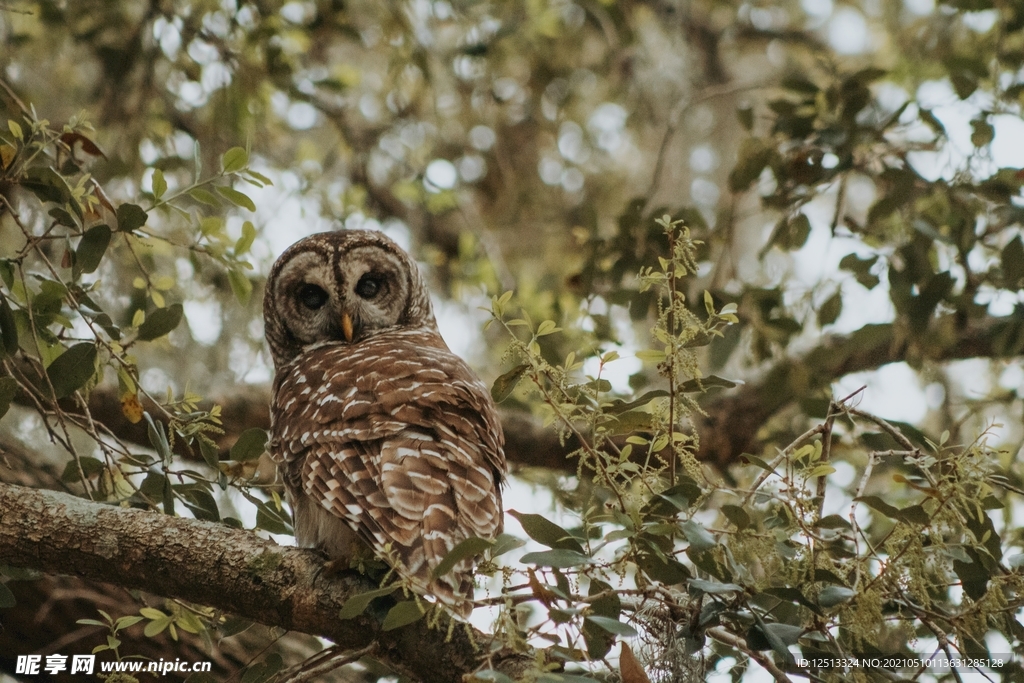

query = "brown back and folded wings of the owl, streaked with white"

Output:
[[273, 331, 505, 613]]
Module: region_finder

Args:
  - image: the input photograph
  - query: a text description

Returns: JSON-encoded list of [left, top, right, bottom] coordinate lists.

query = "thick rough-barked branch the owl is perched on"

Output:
[[0, 484, 521, 683]]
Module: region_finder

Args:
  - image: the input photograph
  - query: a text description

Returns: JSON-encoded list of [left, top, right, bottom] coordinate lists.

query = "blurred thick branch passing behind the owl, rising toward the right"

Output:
[[12, 315, 1024, 470]]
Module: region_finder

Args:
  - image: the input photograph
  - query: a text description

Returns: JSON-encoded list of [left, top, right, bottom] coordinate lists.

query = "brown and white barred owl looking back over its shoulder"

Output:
[[263, 230, 506, 616]]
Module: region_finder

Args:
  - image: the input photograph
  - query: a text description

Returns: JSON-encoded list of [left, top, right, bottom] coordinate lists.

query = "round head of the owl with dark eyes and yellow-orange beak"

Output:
[[263, 230, 437, 368]]
